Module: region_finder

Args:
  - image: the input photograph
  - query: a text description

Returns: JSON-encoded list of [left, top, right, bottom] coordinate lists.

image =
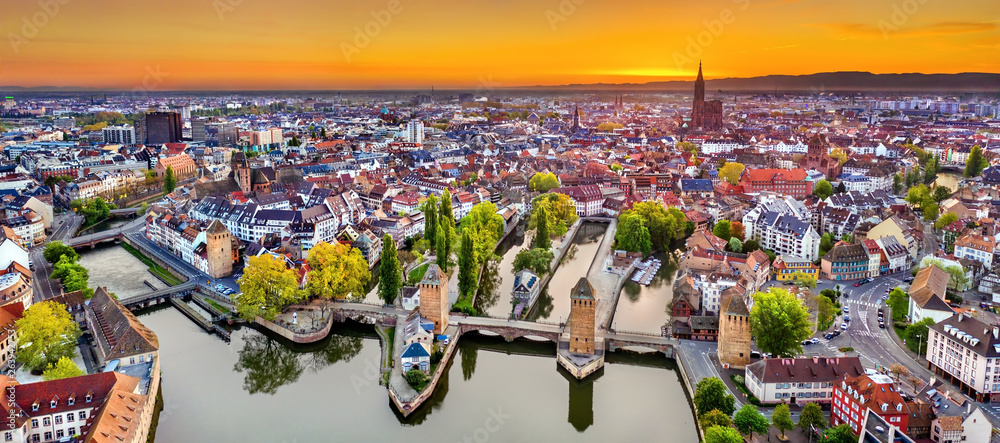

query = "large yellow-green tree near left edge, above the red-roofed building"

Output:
[[16, 301, 80, 371]]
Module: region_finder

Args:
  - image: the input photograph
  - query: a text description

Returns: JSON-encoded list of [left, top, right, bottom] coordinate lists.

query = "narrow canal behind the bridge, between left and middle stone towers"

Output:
[[527, 223, 608, 323]]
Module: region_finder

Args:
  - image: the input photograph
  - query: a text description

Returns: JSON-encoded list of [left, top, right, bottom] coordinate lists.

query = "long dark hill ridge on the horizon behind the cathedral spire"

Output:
[[525, 72, 1000, 93]]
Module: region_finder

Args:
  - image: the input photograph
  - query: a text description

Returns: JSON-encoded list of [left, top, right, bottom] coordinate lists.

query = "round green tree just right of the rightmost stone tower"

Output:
[[750, 287, 813, 357]]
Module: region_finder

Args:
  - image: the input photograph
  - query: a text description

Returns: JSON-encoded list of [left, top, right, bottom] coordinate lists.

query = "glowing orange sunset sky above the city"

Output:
[[0, 0, 1000, 90]]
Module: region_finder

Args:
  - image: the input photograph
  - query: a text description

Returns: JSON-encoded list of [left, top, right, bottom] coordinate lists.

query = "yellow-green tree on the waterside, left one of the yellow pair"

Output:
[[233, 254, 304, 321]]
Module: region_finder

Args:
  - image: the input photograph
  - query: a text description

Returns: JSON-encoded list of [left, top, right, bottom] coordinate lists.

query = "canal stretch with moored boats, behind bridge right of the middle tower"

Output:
[[611, 251, 681, 334]]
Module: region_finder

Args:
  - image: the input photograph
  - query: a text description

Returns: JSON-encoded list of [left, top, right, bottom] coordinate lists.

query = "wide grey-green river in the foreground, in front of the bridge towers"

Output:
[[139, 308, 698, 442]]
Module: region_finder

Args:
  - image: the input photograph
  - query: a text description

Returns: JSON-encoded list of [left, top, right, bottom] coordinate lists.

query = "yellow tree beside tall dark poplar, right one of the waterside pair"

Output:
[[307, 242, 372, 300]]
